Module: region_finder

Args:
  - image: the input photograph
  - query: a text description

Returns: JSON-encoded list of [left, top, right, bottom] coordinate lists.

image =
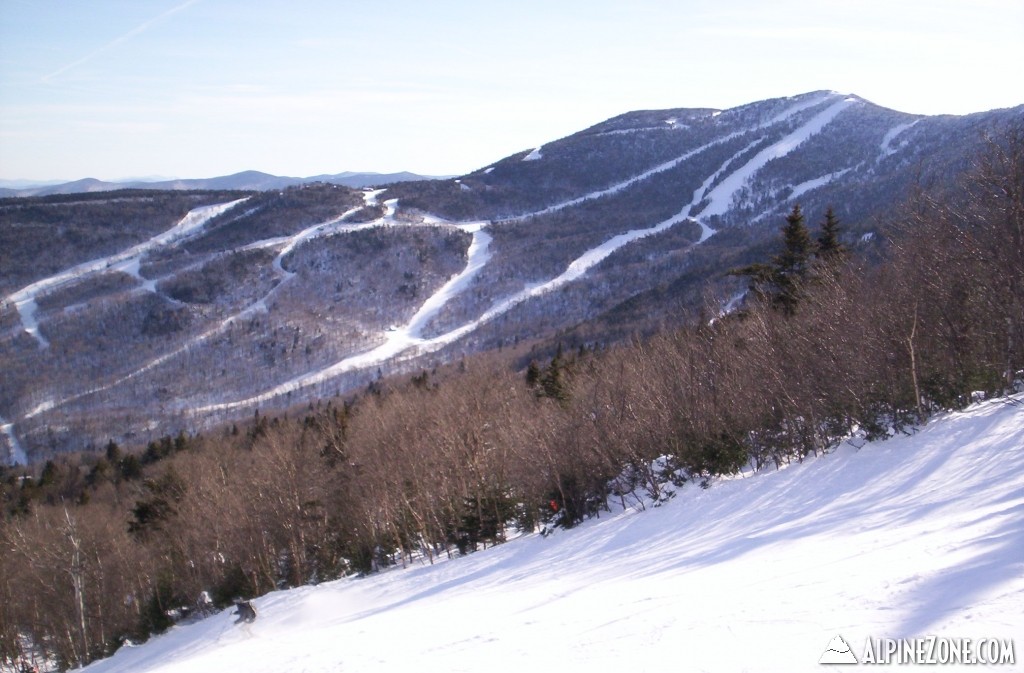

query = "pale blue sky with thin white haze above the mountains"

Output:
[[0, 0, 1024, 180]]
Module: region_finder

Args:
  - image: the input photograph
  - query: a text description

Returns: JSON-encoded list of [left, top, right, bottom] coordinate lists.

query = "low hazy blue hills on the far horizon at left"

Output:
[[0, 171, 444, 197]]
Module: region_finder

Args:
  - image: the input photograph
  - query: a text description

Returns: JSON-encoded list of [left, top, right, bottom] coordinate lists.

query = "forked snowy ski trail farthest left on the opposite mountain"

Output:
[[6, 199, 246, 348]]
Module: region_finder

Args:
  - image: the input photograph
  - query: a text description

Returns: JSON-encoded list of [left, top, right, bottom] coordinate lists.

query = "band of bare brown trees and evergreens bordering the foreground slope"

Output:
[[0, 133, 1024, 667]]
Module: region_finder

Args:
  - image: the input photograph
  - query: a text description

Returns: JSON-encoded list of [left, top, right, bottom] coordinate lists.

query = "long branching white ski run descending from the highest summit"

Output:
[[194, 93, 857, 414]]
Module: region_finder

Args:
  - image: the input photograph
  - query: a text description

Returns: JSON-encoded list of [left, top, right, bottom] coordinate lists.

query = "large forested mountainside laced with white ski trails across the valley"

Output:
[[0, 91, 1024, 459]]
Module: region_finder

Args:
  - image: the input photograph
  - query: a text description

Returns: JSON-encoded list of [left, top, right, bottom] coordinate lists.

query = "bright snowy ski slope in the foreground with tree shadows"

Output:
[[87, 395, 1024, 673]]
